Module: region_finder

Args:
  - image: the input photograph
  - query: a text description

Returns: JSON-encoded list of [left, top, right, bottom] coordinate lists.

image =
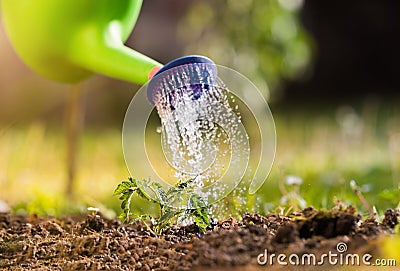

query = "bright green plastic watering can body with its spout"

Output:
[[1, 0, 162, 84]]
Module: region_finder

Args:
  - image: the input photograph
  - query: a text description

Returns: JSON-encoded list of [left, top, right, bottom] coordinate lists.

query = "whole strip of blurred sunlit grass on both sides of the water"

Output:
[[0, 100, 400, 219]]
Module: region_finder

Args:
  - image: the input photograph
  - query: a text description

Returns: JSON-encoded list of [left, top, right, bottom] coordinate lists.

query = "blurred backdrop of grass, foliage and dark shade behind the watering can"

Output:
[[0, 0, 400, 215]]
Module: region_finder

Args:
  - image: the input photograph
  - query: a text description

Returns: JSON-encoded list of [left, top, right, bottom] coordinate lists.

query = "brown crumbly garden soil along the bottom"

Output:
[[0, 207, 399, 271]]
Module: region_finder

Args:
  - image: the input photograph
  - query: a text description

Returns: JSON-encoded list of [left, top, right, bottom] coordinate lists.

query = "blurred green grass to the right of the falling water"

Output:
[[258, 100, 400, 218]]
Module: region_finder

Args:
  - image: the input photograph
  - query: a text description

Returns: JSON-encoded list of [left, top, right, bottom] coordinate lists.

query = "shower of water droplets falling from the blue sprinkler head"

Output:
[[153, 63, 249, 204]]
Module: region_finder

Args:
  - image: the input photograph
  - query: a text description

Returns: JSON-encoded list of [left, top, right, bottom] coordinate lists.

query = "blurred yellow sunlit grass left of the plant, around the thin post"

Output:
[[0, 123, 128, 215]]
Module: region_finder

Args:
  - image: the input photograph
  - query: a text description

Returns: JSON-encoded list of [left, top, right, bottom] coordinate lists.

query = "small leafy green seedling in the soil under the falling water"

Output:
[[114, 177, 210, 235]]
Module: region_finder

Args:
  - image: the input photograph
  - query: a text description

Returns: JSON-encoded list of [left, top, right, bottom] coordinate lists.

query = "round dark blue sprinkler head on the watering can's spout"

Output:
[[147, 55, 217, 109]]
